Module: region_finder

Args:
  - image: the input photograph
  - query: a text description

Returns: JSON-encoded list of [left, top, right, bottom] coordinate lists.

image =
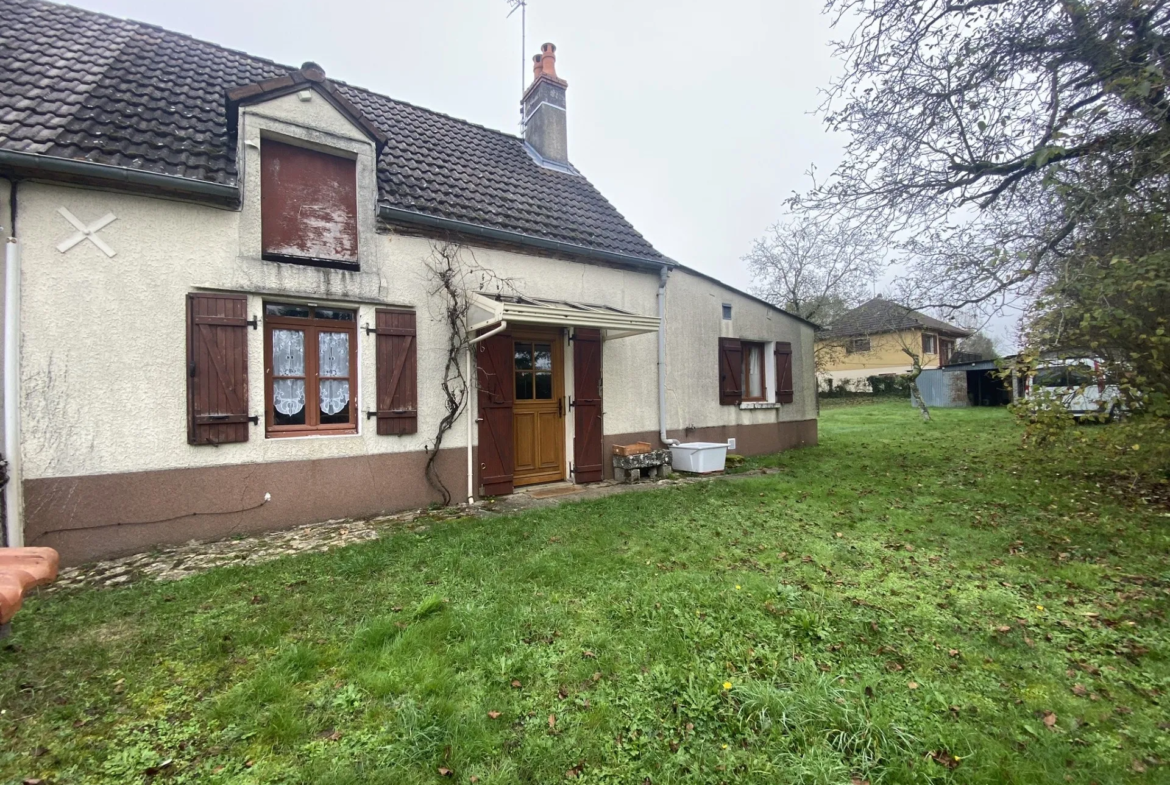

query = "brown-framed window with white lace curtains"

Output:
[[264, 303, 358, 436]]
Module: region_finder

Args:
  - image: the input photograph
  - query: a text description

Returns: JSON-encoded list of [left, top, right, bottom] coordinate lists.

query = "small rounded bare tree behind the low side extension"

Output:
[[743, 216, 885, 326]]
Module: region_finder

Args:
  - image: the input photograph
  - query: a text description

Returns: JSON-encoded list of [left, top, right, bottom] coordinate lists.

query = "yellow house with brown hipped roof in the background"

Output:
[[815, 297, 971, 390]]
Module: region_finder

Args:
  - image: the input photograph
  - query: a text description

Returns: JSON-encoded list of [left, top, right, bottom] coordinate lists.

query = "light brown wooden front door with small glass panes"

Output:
[[512, 329, 565, 486]]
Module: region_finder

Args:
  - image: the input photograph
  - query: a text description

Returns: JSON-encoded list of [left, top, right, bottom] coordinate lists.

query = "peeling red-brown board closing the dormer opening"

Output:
[[260, 139, 358, 270]]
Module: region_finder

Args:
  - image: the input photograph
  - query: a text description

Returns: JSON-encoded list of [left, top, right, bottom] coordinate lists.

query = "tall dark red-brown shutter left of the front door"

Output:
[[475, 332, 516, 496]]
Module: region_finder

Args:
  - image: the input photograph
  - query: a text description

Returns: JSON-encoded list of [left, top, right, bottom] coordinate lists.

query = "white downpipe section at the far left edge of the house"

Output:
[[4, 237, 25, 548]]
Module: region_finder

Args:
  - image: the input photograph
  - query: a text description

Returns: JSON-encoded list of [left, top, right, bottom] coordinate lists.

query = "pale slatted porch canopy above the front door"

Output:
[[468, 291, 659, 340]]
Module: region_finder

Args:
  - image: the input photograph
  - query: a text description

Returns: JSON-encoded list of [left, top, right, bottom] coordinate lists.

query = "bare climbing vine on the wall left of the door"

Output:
[[425, 241, 514, 505]]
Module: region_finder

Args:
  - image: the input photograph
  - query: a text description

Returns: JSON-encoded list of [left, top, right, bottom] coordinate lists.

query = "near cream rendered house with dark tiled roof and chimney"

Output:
[[0, 0, 817, 564]]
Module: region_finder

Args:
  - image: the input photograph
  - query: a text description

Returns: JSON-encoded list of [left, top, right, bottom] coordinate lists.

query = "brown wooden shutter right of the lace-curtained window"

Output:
[[374, 308, 419, 436]]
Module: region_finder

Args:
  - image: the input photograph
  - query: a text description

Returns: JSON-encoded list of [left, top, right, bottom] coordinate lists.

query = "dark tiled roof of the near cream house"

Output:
[[0, 0, 663, 261]]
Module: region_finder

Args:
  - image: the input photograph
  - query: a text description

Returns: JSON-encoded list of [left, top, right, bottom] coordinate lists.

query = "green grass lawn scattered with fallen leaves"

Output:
[[0, 404, 1170, 785]]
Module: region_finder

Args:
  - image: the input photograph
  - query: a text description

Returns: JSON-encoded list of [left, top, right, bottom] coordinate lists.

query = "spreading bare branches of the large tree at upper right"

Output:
[[793, 0, 1170, 308]]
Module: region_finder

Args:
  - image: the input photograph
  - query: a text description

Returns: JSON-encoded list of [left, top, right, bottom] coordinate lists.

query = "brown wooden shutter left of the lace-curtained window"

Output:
[[187, 294, 249, 445]]
